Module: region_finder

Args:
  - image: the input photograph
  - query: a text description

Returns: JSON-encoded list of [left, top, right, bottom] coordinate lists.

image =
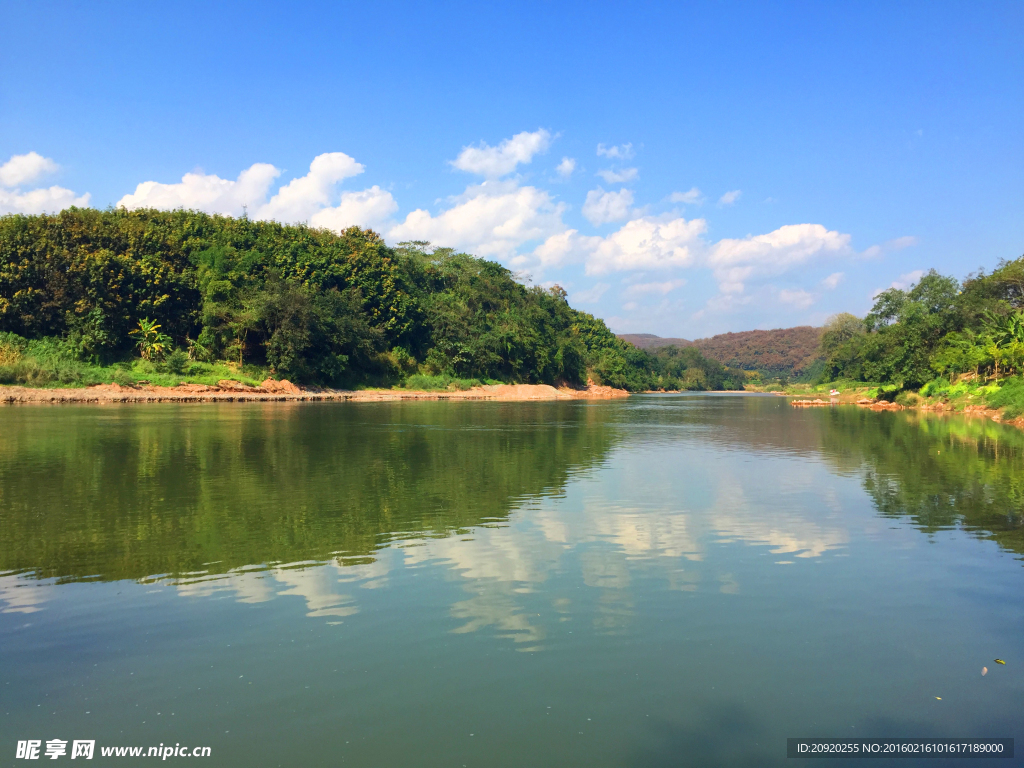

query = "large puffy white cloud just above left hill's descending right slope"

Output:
[[388, 181, 566, 263]]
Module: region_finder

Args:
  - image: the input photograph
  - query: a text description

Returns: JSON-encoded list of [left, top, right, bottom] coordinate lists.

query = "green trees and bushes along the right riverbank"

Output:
[[821, 257, 1024, 415]]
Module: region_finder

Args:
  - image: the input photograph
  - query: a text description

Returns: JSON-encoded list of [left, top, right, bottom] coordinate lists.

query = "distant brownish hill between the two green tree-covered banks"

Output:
[[618, 326, 821, 376]]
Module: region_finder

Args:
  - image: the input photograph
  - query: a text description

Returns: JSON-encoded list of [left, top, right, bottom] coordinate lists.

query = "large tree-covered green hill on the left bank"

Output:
[[0, 208, 741, 391]]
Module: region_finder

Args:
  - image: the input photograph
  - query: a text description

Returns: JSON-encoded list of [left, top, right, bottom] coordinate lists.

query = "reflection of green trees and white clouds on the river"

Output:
[[0, 397, 1024, 630]]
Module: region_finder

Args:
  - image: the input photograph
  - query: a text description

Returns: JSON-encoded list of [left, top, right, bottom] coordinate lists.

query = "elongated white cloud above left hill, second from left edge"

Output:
[[118, 163, 281, 216]]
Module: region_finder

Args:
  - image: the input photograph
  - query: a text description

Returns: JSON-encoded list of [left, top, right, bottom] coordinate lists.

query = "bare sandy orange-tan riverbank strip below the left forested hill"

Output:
[[0, 379, 629, 404]]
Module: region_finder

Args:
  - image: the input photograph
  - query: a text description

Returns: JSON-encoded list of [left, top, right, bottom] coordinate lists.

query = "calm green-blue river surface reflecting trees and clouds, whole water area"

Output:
[[0, 395, 1024, 768]]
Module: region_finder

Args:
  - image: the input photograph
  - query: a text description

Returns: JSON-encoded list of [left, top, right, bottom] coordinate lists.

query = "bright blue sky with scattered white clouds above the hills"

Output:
[[0, 0, 1024, 338]]
